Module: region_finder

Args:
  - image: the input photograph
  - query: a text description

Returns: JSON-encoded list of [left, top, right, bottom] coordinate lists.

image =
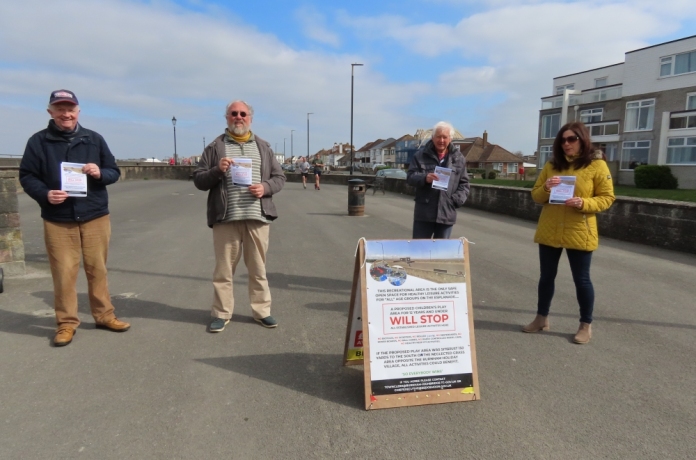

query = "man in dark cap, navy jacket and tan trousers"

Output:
[[19, 90, 130, 347]]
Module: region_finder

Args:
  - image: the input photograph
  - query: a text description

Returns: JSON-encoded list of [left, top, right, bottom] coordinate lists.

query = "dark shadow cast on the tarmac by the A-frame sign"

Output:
[[196, 353, 364, 409]]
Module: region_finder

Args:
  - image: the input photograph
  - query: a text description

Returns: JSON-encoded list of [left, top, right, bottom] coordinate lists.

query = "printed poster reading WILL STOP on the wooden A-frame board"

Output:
[[363, 240, 474, 396]]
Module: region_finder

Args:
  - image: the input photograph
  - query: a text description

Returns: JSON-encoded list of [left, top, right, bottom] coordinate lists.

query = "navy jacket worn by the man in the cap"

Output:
[[19, 120, 121, 222]]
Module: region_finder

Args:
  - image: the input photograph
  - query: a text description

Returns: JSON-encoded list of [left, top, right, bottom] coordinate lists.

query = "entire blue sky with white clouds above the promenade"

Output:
[[0, 0, 696, 158]]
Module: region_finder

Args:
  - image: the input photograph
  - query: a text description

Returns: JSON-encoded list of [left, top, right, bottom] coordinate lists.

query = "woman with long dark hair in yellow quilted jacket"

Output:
[[522, 122, 614, 343]]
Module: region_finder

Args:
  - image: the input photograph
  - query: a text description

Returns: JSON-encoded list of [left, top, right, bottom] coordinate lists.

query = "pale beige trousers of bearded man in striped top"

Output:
[[211, 220, 271, 319]]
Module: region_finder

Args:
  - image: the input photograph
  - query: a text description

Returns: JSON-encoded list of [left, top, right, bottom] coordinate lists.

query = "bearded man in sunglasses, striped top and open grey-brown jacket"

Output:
[[193, 100, 285, 332]]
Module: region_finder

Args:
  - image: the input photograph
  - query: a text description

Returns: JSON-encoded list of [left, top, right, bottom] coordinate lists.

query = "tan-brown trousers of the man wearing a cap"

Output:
[[44, 215, 114, 328]]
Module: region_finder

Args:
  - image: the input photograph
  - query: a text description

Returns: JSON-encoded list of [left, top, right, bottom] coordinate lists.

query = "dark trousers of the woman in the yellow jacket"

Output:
[[537, 244, 594, 324]]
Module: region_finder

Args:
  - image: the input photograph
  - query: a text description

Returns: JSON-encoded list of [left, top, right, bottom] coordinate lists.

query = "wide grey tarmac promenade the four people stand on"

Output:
[[0, 181, 696, 459]]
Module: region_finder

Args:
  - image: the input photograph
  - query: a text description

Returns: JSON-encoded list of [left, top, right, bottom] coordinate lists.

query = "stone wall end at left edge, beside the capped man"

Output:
[[0, 170, 25, 275]]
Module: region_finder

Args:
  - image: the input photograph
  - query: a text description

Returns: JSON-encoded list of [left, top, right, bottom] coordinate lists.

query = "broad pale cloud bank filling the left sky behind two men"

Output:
[[0, 0, 428, 157]]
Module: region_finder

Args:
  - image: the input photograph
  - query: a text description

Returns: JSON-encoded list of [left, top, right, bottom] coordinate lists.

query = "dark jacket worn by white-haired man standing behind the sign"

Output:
[[406, 140, 469, 225]]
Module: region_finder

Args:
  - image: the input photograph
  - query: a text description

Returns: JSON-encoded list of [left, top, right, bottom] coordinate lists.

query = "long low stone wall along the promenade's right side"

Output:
[[288, 174, 696, 253]]
